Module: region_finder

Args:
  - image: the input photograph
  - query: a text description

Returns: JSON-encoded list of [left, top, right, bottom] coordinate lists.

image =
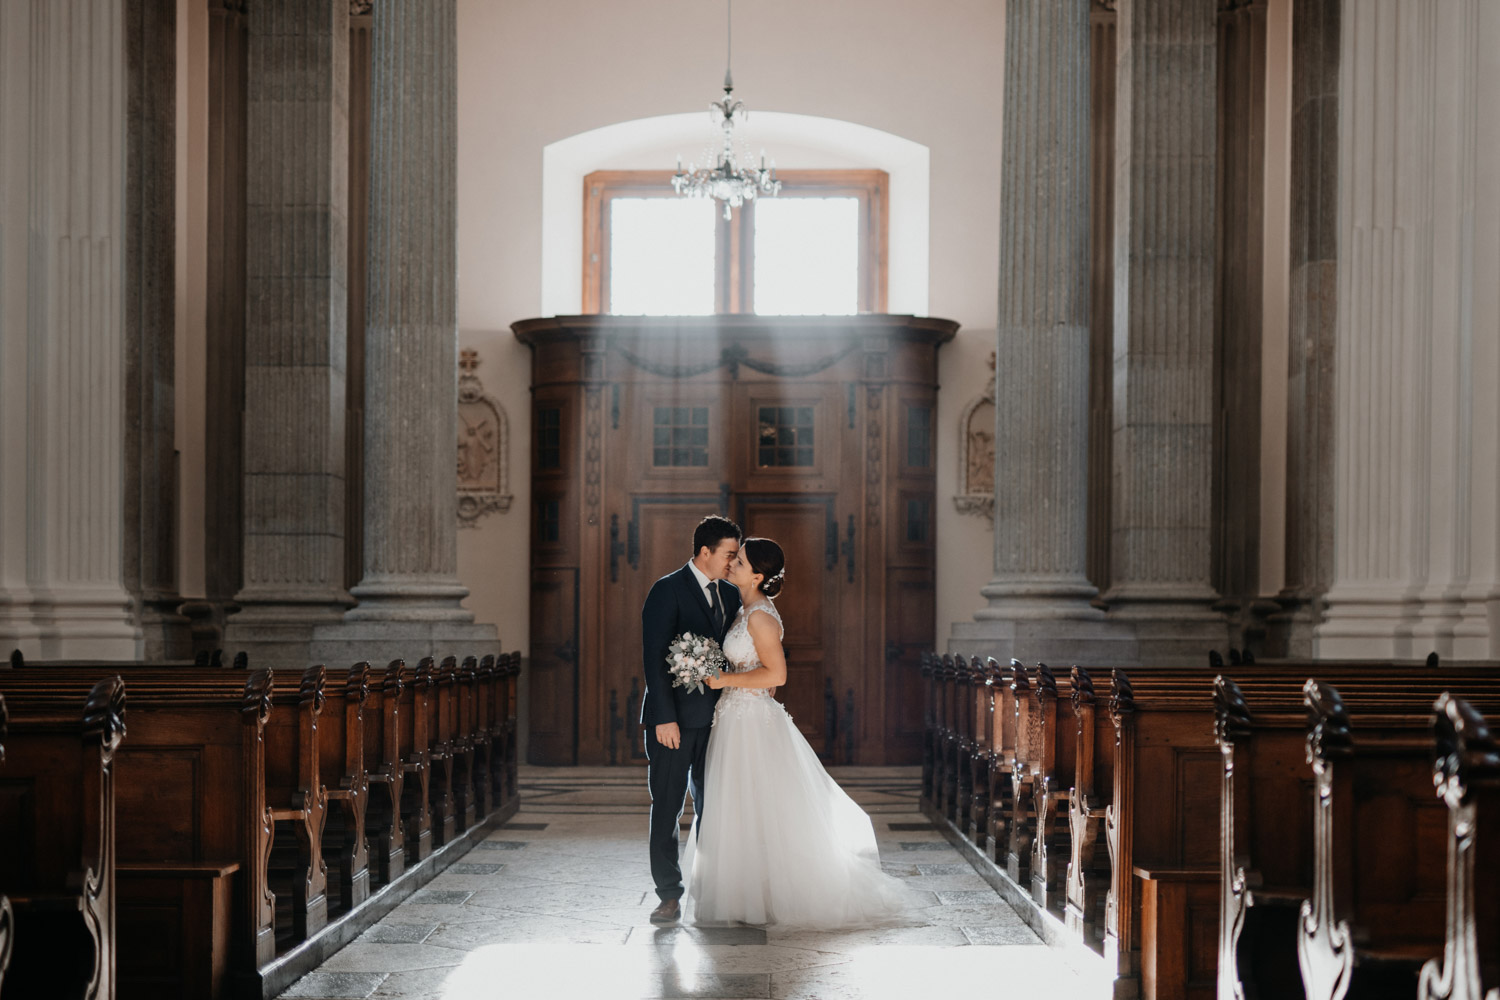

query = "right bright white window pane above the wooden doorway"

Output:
[[755, 198, 860, 316]]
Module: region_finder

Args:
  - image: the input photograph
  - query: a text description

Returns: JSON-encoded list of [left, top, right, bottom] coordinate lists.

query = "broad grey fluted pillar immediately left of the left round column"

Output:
[[225, 0, 350, 666]]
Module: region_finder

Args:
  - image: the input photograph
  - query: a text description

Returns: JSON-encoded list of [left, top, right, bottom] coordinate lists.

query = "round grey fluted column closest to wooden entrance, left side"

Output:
[[315, 0, 495, 661]]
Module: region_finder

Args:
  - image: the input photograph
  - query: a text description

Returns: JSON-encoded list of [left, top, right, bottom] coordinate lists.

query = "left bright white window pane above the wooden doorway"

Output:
[[609, 198, 714, 316]]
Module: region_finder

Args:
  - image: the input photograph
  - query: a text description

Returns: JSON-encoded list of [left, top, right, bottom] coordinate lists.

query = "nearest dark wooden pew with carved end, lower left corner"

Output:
[[0, 676, 125, 1000]]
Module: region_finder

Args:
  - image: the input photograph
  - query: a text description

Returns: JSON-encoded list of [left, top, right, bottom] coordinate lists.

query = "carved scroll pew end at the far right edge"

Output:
[[1418, 693, 1500, 1000]]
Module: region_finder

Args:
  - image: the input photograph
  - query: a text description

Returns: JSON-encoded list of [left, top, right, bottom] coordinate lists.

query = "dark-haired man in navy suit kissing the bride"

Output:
[[641, 514, 741, 924]]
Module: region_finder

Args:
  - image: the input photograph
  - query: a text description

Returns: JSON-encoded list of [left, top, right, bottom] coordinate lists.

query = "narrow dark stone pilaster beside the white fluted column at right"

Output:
[[1271, 0, 1343, 657]]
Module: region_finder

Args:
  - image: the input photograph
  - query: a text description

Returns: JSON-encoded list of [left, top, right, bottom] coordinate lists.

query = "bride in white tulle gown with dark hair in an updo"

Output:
[[684, 538, 912, 928]]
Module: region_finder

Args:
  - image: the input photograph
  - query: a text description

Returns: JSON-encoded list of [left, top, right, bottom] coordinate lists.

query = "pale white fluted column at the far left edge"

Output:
[[0, 0, 138, 658]]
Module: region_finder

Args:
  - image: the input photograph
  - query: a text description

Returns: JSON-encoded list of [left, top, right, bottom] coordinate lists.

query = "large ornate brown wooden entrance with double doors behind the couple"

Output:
[[512, 315, 959, 765]]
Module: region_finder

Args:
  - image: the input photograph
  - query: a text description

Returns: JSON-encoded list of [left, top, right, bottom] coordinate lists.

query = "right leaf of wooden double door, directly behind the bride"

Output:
[[735, 493, 845, 760]]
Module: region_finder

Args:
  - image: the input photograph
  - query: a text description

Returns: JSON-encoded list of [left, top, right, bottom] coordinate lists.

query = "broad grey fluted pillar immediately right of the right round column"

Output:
[[1106, 0, 1229, 663]]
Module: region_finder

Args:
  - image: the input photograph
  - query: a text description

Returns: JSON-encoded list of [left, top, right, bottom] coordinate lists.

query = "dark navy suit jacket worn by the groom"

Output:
[[641, 565, 740, 729]]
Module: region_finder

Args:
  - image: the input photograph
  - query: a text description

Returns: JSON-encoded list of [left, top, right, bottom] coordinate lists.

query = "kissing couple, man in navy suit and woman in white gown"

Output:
[[641, 516, 912, 930]]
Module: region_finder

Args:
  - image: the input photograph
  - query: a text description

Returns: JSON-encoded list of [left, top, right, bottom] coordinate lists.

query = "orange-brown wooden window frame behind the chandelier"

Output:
[[582, 169, 890, 315]]
